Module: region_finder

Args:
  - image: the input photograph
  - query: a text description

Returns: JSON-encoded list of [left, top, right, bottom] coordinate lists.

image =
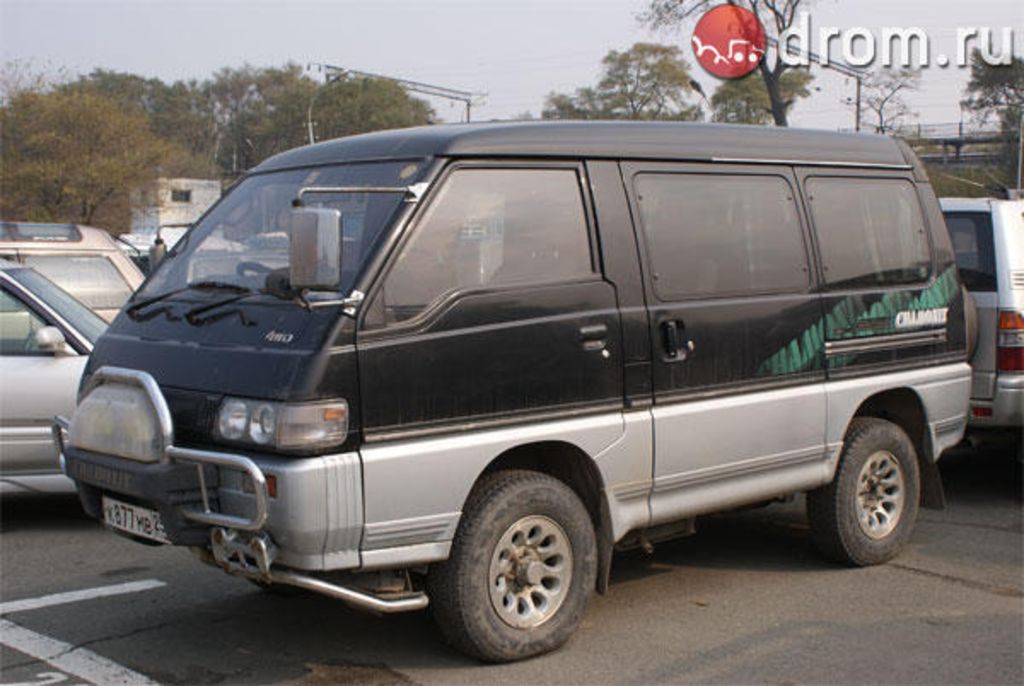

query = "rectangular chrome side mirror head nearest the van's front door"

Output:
[[288, 207, 341, 291]]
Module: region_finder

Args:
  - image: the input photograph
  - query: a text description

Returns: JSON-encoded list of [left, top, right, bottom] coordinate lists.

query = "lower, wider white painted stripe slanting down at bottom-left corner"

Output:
[[0, 619, 157, 686]]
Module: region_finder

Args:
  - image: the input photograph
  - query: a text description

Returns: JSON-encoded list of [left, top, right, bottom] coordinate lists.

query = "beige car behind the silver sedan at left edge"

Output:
[[0, 221, 143, 321]]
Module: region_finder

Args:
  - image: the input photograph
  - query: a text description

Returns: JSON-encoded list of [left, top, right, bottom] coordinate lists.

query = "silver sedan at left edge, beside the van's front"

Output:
[[0, 260, 106, 477]]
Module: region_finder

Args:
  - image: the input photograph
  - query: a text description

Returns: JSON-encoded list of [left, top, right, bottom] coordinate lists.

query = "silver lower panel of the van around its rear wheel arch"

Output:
[[825, 362, 971, 460]]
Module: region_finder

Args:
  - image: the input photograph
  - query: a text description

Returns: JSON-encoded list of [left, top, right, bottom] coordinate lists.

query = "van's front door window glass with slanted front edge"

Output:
[[378, 169, 593, 323]]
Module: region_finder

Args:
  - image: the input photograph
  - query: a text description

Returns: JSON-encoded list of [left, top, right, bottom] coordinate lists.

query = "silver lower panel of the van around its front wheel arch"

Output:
[[361, 412, 630, 566]]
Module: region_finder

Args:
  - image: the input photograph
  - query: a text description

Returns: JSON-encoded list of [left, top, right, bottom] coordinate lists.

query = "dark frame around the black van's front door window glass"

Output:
[[356, 159, 604, 340]]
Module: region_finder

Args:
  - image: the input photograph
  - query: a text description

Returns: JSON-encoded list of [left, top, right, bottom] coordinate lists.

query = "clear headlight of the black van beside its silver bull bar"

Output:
[[216, 398, 348, 453]]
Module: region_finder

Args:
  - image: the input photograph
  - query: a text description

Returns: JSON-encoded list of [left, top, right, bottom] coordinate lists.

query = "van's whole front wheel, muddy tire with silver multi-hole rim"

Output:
[[427, 471, 597, 662]]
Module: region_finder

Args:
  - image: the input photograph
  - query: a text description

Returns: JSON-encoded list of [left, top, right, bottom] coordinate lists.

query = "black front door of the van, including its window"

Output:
[[357, 164, 623, 441]]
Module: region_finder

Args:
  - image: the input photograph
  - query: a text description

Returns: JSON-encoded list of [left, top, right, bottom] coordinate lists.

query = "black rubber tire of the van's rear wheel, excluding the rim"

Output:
[[807, 417, 921, 566]]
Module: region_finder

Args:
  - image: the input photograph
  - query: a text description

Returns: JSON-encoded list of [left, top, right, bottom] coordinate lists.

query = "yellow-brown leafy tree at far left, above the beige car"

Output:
[[0, 90, 175, 232]]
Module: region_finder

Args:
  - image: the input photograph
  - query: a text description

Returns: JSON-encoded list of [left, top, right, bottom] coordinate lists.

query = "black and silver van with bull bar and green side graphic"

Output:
[[54, 122, 971, 661]]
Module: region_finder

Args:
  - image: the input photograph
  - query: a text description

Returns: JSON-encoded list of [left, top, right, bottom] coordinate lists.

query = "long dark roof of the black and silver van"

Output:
[[253, 121, 912, 172]]
